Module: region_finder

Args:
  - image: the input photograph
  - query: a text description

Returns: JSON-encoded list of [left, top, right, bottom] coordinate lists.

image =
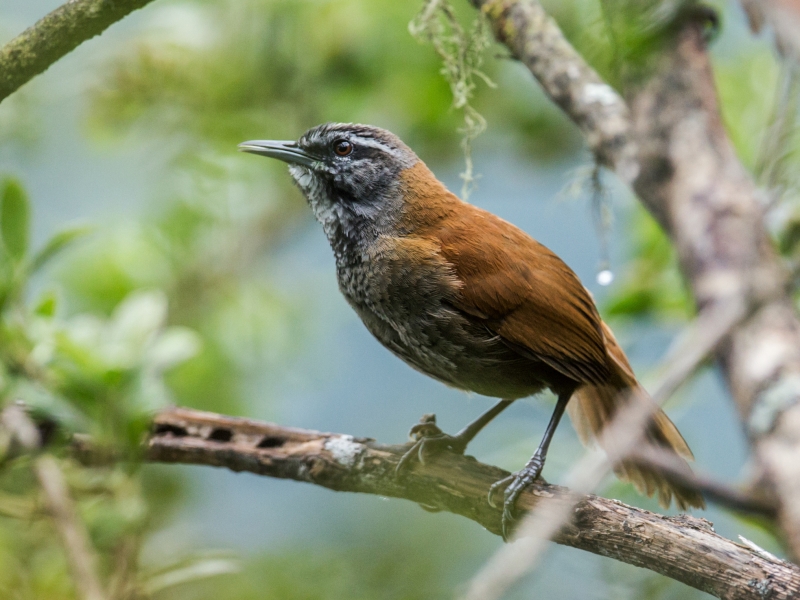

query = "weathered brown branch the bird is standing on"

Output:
[[146, 409, 800, 600]]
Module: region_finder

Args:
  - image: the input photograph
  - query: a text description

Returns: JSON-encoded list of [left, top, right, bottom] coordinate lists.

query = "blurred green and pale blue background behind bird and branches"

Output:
[[0, 0, 795, 600]]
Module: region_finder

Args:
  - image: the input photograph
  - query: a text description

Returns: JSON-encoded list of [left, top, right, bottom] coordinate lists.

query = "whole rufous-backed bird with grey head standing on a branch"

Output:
[[239, 123, 704, 537]]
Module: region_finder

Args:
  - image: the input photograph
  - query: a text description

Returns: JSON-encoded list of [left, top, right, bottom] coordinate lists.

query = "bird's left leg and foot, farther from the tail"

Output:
[[397, 400, 513, 473]]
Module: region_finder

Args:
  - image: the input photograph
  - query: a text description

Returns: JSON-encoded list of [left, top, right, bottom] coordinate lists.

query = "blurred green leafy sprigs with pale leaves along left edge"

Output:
[[0, 180, 212, 598]]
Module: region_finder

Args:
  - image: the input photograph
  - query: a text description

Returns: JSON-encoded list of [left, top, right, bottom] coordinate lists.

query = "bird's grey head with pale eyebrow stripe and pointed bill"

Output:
[[239, 123, 419, 242]]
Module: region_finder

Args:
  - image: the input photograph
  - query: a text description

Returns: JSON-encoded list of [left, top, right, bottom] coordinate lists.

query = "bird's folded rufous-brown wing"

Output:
[[436, 206, 609, 383]]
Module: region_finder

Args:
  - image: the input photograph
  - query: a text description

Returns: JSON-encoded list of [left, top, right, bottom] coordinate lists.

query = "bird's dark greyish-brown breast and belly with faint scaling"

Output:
[[337, 238, 545, 398]]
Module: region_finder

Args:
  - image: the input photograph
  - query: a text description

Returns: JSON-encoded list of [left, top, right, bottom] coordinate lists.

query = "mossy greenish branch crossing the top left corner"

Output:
[[0, 0, 158, 102]]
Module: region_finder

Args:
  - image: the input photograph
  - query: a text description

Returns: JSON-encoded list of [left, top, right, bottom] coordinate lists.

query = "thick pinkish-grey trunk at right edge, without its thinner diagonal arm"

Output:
[[631, 19, 800, 556]]
